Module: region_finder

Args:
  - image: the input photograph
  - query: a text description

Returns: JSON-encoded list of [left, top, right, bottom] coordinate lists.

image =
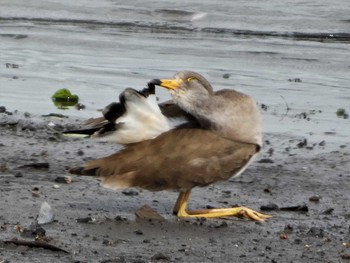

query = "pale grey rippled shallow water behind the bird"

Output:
[[0, 0, 350, 142]]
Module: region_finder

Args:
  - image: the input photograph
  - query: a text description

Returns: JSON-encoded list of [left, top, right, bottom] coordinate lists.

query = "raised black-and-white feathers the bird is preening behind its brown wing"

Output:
[[63, 83, 195, 145]]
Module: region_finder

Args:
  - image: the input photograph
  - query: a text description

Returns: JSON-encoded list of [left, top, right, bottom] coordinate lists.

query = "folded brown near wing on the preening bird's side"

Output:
[[83, 129, 258, 191]]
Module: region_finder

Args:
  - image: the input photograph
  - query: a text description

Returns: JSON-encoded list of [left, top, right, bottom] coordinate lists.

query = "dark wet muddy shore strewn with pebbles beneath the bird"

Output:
[[0, 110, 350, 263]]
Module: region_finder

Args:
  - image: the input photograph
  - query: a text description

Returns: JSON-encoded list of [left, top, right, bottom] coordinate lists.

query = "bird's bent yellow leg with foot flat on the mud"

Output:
[[178, 191, 271, 221]]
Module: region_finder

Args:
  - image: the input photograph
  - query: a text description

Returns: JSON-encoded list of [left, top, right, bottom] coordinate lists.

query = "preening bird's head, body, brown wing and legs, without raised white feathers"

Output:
[[70, 71, 271, 221]]
